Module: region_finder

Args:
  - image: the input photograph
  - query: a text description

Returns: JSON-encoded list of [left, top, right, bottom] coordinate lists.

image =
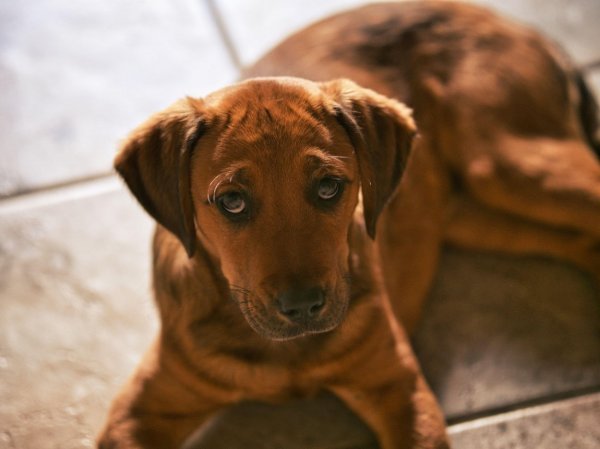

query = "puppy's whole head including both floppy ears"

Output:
[[115, 78, 415, 340]]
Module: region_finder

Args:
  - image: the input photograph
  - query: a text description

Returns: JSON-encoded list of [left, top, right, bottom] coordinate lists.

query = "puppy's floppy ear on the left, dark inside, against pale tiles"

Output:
[[114, 98, 205, 257]]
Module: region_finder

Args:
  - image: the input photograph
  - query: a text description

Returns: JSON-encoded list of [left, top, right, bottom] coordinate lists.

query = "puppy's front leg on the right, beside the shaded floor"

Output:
[[329, 304, 449, 449]]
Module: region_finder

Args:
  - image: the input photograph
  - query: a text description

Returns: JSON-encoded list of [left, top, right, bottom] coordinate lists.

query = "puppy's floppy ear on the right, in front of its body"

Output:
[[322, 80, 417, 238]]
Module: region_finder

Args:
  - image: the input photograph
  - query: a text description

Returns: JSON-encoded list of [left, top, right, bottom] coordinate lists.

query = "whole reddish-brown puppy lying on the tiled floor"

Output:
[[99, 2, 600, 449]]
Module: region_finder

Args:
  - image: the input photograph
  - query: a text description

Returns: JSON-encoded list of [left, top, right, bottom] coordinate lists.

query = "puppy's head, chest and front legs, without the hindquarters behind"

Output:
[[100, 78, 447, 449]]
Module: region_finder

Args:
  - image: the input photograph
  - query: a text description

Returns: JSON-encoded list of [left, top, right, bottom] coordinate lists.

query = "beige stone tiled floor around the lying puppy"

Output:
[[0, 0, 600, 449]]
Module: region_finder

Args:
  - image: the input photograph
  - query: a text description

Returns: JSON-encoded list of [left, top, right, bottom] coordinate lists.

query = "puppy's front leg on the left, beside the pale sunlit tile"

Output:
[[98, 344, 221, 449]]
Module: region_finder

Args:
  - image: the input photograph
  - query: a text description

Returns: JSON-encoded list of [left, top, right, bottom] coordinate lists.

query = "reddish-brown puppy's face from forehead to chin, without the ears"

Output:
[[191, 83, 360, 339]]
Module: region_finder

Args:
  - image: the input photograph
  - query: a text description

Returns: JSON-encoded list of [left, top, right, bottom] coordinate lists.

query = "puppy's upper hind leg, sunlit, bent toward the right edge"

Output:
[[462, 136, 600, 237]]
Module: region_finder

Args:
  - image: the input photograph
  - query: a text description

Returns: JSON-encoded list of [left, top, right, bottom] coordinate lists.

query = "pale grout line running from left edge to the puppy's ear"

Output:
[[0, 175, 121, 215]]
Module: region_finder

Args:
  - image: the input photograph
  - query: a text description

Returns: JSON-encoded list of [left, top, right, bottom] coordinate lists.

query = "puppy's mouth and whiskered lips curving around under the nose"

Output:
[[232, 291, 349, 341]]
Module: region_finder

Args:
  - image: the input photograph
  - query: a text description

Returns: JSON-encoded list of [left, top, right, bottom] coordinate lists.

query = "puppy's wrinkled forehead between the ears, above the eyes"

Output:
[[200, 81, 353, 171]]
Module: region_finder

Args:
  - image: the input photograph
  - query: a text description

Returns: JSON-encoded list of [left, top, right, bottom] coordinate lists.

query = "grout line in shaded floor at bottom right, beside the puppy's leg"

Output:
[[447, 385, 600, 433]]
